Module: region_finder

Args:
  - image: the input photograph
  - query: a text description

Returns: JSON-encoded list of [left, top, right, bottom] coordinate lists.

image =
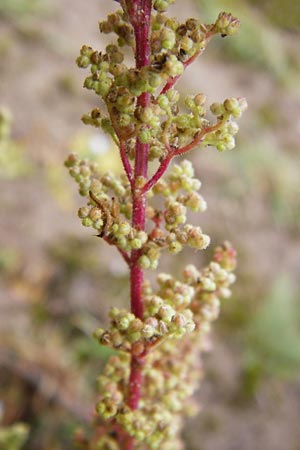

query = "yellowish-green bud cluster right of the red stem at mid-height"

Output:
[[139, 160, 210, 269]]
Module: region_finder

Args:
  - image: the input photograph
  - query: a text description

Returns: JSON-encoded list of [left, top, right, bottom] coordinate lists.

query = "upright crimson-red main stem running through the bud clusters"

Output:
[[126, 0, 152, 450]]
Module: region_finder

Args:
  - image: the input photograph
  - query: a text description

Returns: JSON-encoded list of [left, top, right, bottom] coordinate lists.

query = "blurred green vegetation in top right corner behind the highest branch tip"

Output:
[[197, 0, 300, 89]]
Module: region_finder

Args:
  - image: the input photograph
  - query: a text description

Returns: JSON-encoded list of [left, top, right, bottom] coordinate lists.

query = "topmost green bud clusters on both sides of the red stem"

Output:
[[77, 5, 246, 159]]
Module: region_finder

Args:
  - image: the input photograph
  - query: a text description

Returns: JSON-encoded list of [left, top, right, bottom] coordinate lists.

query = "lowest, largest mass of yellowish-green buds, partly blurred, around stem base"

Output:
[[92, 242, 236, 450]]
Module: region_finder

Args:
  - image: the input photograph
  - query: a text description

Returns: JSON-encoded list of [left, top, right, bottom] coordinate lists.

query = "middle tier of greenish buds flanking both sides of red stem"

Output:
[[65, 153, 210, 269]]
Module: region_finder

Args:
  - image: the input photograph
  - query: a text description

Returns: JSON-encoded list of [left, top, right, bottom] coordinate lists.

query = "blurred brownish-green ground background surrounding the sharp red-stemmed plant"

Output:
[[0, 0, 300, 450]]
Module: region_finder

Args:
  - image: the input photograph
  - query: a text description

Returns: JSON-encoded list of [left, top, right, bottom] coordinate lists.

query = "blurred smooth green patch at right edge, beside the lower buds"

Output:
[[244, 276, 300, 379]]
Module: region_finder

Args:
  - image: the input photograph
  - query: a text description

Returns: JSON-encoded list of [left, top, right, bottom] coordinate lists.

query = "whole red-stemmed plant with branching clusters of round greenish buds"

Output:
[[65, 0, 247, 450]]
